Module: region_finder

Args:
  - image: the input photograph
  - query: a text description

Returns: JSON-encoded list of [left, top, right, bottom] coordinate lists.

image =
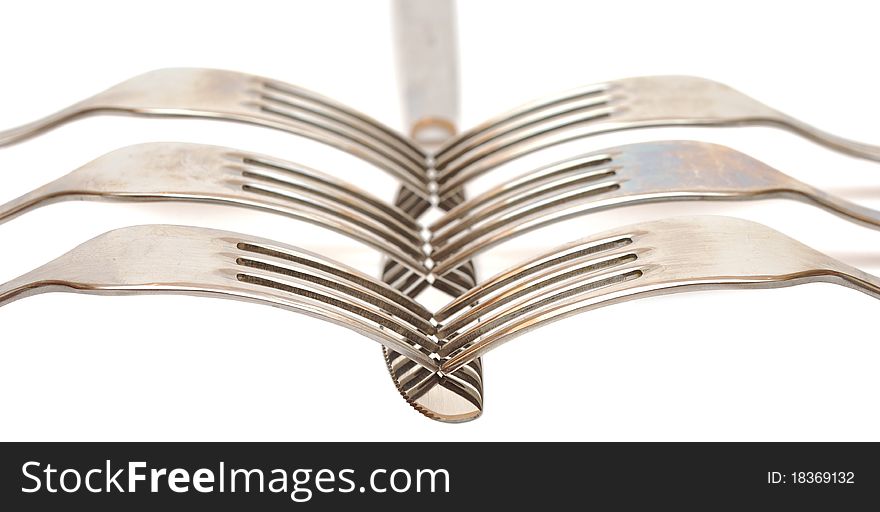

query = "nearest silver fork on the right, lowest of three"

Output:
[[435, 217, 880, 372]]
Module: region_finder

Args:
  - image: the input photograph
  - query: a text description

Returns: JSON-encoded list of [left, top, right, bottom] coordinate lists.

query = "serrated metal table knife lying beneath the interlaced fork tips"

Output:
[[382, 0, 483, 422]]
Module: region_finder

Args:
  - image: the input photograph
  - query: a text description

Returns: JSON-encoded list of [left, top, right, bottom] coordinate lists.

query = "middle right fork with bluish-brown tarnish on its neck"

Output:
[[430, 141, 880, 276]]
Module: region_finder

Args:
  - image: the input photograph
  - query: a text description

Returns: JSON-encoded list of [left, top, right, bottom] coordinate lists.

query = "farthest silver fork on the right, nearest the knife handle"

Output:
[[435, 76, 880, 204]]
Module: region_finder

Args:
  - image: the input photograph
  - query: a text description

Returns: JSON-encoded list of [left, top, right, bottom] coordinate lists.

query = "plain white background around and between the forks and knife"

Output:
[[0, 0, 880, 440]]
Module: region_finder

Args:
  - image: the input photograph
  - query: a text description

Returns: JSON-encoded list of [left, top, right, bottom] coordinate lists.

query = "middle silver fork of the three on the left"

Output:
[[0, 143, 427, 275]]
